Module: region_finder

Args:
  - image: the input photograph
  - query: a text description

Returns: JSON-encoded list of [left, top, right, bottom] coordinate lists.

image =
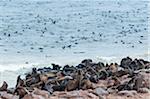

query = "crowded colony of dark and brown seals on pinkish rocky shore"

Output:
[[0, 57, 150, 99]]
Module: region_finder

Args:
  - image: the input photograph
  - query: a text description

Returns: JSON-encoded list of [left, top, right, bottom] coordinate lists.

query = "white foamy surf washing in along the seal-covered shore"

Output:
[[0, 56, 150, 87]]
